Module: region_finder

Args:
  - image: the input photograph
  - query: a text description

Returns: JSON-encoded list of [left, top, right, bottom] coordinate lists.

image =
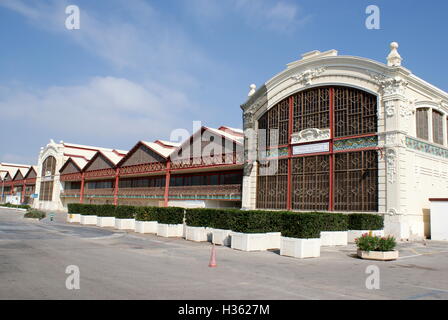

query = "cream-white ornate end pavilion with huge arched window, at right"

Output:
[[241, 42, 448, 239]]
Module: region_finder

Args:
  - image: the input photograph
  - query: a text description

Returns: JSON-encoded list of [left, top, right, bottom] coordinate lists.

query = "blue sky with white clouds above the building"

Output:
[[0, 0, 448, 164]]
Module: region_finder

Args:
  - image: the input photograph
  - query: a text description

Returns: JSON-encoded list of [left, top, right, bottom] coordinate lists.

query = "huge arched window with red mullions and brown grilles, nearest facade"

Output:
[[256, 86, 378, 212]]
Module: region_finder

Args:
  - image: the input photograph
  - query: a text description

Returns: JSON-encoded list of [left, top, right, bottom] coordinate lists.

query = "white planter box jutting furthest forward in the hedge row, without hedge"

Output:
[[280, 237, 320, 259]]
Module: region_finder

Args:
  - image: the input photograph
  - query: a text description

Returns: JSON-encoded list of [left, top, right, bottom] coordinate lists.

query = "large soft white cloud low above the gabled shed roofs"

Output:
[[0, 77, 194, 141]]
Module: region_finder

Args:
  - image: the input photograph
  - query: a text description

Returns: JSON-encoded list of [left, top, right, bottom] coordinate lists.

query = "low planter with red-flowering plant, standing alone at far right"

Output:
[[355, 233, 399, 261]]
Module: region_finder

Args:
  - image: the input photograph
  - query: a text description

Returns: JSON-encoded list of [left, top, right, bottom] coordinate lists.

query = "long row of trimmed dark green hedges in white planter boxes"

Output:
[[68, 203, 384, 239]]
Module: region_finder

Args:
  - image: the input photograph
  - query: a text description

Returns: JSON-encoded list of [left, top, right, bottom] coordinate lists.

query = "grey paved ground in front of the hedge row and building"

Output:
[[0, 209, 448, 299]]
